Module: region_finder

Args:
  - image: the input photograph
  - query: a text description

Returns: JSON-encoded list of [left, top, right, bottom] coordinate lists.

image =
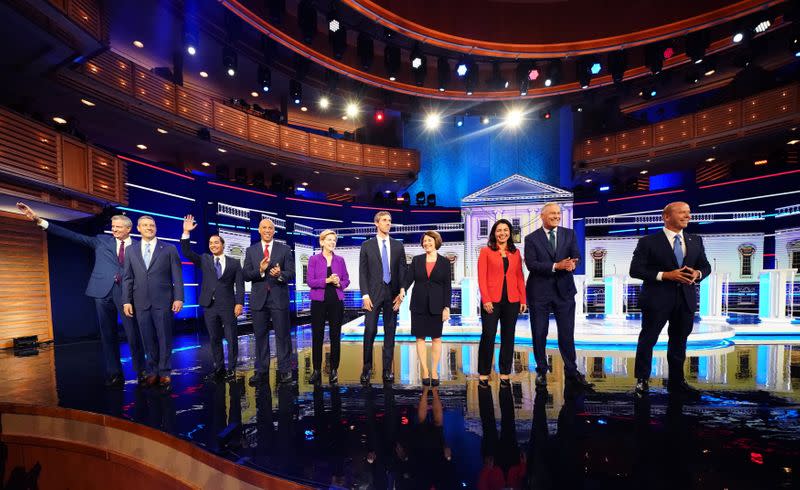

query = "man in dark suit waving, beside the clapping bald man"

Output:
[[181, 214, 244, 381]]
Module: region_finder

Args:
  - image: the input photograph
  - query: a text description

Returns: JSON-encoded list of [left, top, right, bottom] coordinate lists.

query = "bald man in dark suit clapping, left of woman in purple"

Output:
[[243, 218, 294, 386]]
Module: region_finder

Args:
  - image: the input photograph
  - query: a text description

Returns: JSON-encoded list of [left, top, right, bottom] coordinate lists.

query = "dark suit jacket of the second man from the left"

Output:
[[122, 240, 183, 311]]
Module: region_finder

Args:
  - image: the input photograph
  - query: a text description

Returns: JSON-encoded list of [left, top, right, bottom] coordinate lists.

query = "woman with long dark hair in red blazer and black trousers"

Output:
[[478, 219, 527, 388]]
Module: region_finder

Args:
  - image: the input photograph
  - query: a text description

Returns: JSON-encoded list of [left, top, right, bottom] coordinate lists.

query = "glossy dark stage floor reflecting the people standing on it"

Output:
[[0, 329, 800, 489]]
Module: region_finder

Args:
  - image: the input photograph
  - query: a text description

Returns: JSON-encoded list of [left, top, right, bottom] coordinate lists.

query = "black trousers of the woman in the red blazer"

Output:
[[478, 301, 519, 376]]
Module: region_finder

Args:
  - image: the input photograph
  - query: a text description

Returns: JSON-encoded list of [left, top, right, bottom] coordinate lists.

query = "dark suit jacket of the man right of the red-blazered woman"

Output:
[[525, 226, 581, 303]]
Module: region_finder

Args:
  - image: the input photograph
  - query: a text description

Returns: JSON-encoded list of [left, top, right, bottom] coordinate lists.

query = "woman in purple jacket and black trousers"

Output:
[[306, 230, 350, 386]]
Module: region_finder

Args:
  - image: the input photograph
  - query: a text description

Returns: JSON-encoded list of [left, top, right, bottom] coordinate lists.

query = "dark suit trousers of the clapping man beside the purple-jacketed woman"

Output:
[[253, 305, 292, 374]]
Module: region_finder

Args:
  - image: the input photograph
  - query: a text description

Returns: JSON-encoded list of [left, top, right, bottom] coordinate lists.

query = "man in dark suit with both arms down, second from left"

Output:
[[122, 216, 183, 390]]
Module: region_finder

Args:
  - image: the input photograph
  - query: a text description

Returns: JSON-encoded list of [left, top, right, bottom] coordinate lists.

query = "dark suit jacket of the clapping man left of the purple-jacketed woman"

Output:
[[242, 240, 294, 311]]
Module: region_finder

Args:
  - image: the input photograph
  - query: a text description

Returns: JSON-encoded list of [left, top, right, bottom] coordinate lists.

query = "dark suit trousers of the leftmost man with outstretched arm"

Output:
[[94, 284, 144, 376]]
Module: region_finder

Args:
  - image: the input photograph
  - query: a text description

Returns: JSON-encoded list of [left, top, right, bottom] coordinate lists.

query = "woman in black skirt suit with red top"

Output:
[[404, 231, 452, 386]]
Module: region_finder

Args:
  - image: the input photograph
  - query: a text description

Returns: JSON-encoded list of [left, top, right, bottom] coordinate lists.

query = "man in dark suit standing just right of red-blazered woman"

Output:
[[525, 202, 592, 389]]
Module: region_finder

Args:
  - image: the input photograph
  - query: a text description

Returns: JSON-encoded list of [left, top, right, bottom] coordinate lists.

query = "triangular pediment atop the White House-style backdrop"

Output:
[[461, 174, 572, 206]]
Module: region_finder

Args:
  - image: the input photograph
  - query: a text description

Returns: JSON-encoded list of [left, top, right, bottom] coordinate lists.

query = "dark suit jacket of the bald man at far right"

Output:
[[630, 230, 711, 311]]
